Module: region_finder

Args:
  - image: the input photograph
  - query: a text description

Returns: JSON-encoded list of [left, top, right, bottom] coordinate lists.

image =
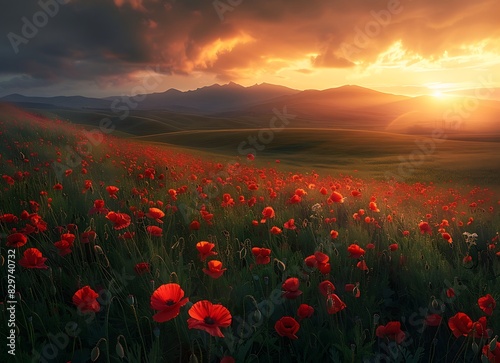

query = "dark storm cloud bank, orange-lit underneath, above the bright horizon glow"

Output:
[[0, 0, 500, 95]]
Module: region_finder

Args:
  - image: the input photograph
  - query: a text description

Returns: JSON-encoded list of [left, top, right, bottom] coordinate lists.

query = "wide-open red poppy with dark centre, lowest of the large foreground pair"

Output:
[[187, 300, 232, 338]]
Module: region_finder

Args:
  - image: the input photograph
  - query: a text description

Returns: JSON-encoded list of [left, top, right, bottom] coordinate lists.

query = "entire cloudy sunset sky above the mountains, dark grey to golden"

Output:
[[0, 0, 500, 97]]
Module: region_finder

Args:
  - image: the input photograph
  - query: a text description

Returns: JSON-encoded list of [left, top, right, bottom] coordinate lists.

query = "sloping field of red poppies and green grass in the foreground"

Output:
[[0, 104, 500, 363]]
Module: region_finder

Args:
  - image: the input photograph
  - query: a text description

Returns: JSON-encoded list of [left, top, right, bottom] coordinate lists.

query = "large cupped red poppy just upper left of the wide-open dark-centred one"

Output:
[[150, 283, 189, 323]]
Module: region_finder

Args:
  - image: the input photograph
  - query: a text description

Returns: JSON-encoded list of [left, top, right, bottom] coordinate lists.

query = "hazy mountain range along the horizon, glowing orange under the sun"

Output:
[[0, 82, 500, 134]]
